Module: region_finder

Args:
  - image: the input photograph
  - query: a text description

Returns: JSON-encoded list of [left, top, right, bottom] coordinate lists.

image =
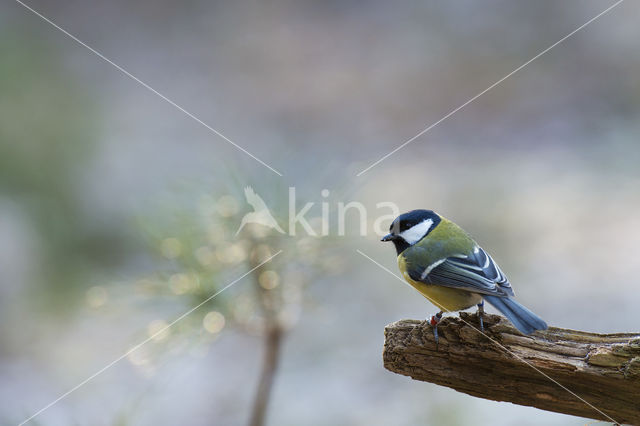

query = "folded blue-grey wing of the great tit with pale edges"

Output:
[[411, 246, 514, 297]]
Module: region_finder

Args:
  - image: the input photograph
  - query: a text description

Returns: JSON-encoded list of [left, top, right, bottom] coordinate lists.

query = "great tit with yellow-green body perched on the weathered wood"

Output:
[[382, 210, 547, 342]]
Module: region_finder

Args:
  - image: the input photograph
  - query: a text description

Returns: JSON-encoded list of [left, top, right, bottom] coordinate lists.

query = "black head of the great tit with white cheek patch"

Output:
[[380, 210, 442, 254]]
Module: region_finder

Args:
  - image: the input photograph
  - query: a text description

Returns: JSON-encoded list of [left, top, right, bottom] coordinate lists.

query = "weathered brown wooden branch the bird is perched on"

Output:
[[383, 312, 640, 425]]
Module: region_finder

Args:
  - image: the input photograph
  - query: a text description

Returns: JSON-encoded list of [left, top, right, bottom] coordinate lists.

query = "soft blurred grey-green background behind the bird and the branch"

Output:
[[0, 0, 640, 425]]
